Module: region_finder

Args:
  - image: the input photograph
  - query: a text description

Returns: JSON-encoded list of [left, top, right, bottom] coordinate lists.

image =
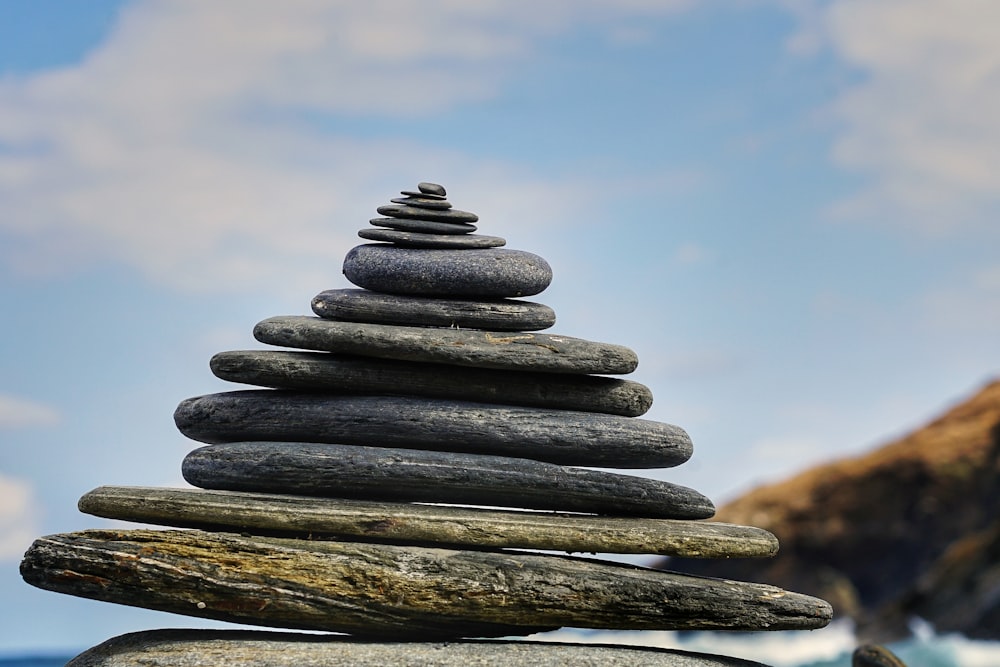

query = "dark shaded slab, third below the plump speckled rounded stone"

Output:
[[209, 350, 653, 417]]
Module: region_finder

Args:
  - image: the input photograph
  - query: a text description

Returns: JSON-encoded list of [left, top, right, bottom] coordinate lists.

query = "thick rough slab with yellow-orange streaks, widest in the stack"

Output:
[[21, 530, 832, 638]]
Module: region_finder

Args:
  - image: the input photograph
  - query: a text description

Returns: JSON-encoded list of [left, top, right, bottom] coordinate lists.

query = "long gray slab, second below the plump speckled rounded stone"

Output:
[[253, 314, 639, 375]]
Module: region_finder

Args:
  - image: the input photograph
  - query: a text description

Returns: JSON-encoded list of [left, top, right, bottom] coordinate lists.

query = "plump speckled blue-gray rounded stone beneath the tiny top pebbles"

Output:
[[344, 244, 552, 297]]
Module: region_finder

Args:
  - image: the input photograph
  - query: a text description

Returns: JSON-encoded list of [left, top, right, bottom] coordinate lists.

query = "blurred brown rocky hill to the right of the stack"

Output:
[[660, 381, 1000, 641]]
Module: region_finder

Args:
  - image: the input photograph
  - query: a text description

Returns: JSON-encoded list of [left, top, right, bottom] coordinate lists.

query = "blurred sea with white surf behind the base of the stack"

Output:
[[0, 620, 1000, 667]]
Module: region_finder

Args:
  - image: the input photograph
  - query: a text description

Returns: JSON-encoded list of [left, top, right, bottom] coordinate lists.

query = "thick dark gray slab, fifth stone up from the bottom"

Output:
[[174, 389, 692, 468]]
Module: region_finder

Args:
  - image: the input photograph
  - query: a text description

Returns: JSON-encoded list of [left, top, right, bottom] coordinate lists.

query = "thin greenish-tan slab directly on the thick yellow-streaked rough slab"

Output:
[[79, 486, 778, 558]]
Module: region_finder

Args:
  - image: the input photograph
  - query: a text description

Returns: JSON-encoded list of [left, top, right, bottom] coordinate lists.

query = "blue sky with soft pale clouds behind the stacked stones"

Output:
[[0, 0, 1000, 652]]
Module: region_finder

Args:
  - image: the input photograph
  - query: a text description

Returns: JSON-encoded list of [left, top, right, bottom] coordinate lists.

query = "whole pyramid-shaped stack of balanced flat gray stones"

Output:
[[21, 183, 831, 665]]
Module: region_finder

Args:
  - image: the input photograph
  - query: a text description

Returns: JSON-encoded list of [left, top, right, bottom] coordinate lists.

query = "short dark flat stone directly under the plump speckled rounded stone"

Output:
[[312, 289, 556, 331]]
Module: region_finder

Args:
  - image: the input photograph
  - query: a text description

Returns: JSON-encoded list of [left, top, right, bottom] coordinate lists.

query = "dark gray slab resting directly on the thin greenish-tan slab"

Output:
[[182, 442, 715, 519]]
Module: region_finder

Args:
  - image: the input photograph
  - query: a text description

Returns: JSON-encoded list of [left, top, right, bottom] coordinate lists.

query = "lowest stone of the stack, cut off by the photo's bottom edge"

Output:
[[66, 630, 767, 667]]
